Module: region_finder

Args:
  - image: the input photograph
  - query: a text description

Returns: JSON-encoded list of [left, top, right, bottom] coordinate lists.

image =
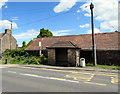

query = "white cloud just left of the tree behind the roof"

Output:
[[13, 29, 39, 39]]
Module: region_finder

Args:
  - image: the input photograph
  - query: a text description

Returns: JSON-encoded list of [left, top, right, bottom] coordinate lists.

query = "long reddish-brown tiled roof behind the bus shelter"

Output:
[[25, 32, 120, 50]]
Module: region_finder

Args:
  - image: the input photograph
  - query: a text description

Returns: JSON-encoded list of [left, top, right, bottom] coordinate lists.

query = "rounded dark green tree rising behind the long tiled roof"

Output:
[[37, 28, 53, 38]]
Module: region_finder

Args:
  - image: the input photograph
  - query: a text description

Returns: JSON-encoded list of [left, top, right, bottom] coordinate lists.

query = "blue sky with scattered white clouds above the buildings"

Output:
[[0, 0, 118, 46]]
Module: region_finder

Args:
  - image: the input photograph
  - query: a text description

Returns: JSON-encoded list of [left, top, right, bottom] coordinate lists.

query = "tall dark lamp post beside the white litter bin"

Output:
[[90, 3, 97, 66]]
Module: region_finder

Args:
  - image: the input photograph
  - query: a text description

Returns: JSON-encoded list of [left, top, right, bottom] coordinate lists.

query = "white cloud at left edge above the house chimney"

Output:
[[0, 20, 18, 29]]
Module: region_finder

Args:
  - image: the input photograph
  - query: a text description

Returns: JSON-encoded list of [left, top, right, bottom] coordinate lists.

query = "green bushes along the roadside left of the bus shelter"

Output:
[[2, 49, 47, 65]]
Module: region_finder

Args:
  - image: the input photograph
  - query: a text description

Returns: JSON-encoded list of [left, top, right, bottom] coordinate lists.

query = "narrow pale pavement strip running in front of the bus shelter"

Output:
[[9, 65, 119, 73]]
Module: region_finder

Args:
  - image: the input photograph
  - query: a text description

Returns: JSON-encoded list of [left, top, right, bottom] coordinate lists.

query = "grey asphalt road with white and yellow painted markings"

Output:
[[0, 65, 118, 92]]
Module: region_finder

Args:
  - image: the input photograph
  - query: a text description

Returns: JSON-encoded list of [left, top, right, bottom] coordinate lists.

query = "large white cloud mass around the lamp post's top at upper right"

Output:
[[80, 0, 118, 30]]
